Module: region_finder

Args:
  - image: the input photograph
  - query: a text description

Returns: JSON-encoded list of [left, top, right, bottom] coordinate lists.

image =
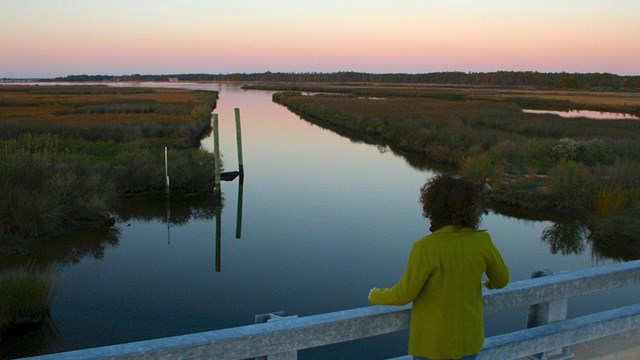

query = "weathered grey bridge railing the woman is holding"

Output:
[[22, 261, 640, 360]]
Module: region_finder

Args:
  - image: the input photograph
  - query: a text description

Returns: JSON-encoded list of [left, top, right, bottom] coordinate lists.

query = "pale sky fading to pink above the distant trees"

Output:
[[0, 0, 640, 78]]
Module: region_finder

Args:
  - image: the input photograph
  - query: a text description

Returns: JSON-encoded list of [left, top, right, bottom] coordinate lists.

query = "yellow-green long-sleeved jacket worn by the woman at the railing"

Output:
[[370, 225, 509, 359]]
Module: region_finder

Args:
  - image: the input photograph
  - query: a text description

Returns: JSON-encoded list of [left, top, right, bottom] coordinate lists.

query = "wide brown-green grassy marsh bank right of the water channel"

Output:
[[274, 87, 640, 249]]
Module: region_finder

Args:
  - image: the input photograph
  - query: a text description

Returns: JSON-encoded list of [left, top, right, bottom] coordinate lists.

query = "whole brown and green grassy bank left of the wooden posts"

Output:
[[0, 86, 216, 244]]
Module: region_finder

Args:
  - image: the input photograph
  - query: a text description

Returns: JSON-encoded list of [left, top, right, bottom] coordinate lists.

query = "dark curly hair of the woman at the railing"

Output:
[[420, 175, 482, 231]]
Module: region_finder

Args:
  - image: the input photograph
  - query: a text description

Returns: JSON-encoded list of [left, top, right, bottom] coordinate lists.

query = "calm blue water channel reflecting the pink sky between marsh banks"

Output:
[[0, 83, 640, 359]]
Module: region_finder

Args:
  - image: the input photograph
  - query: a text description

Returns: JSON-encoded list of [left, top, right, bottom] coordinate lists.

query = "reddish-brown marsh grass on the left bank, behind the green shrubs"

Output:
[[0, 86, 215, 148]]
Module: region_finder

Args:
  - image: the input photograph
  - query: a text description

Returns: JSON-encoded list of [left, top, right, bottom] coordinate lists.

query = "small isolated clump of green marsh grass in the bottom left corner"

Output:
[[0, 263, 60, 333]]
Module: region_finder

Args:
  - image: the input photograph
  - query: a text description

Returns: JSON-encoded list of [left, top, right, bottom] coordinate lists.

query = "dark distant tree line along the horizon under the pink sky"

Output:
[[43, 71, 640, 90]]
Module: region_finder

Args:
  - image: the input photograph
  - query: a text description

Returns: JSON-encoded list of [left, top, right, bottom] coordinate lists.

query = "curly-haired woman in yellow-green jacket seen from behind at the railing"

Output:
[[369, 175, 509, 359]]
